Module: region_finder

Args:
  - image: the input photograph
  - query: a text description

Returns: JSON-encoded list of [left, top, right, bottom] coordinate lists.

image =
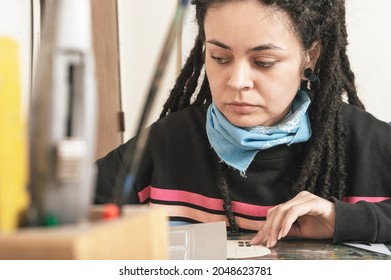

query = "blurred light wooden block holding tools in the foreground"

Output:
[[0, 206, 168, 260]]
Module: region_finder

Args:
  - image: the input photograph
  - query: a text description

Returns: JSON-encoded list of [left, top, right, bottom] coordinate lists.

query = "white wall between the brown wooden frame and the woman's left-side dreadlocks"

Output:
[[117, 0, 177, 141]]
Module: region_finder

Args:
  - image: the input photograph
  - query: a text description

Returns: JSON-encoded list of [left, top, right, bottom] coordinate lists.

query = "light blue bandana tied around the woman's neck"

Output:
[[206, 90, 311, 176]]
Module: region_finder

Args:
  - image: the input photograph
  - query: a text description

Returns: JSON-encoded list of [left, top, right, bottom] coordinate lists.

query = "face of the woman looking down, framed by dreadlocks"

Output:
[[204, 1, 306, 127]]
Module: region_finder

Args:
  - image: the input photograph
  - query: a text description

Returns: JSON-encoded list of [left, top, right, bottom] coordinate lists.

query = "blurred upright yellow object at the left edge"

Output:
[[0, 37, 28, 232]]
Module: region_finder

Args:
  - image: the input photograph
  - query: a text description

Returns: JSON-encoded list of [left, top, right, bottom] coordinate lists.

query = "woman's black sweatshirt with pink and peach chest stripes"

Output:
[[95, 104, 391, 242]]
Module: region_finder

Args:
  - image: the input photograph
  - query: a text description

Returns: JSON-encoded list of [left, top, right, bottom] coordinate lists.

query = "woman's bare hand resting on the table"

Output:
[[251, 191, 335, 247]]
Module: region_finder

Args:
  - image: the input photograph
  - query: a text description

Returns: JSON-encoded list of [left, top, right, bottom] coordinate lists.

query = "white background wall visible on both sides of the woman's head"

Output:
[[118, 0, 391, 140]]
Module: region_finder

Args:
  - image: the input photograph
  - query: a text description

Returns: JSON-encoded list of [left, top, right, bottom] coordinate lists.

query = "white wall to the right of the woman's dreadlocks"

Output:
[[346, 0, 391, 122]]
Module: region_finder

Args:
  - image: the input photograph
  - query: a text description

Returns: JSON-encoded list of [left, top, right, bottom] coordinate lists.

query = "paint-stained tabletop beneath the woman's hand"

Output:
[[228, 234, 391, 260]]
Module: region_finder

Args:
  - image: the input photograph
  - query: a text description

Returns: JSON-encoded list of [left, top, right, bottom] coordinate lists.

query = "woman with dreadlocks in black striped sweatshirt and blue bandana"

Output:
[[96, 0, 391, 247]]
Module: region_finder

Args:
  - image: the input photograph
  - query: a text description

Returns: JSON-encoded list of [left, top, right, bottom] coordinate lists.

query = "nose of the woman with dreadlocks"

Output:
[[227, 62, 253, 91]]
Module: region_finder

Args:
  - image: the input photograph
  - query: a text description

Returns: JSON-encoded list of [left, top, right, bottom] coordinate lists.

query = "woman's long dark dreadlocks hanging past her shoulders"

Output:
[[160, 0, 364, 232]]
